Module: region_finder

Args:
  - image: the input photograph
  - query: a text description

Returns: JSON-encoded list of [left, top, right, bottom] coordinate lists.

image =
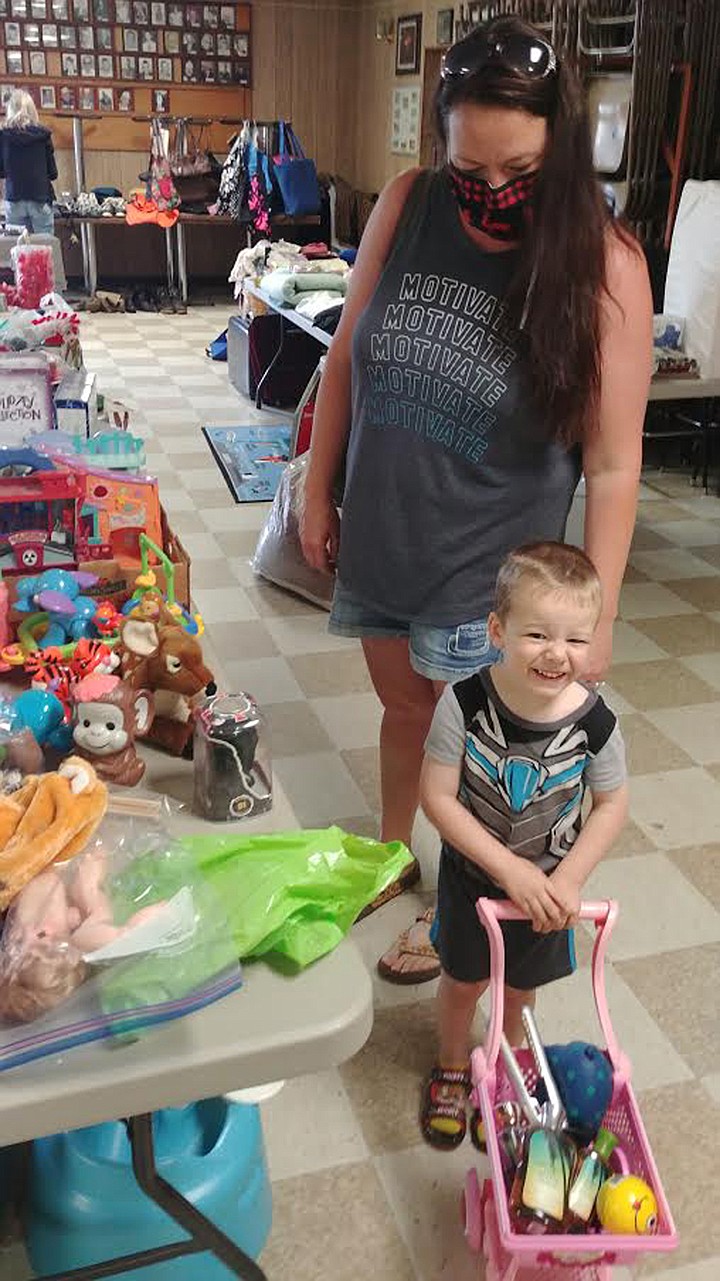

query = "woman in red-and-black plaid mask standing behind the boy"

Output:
[[302, 17, 652, 983]]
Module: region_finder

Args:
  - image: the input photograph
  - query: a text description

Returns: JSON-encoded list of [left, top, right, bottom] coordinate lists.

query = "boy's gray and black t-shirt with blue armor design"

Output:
[[425, 667, 626, 872]]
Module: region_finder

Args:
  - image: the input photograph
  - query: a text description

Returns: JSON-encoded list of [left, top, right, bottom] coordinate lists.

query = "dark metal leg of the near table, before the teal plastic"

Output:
[[30, 1113, 268, 1281]]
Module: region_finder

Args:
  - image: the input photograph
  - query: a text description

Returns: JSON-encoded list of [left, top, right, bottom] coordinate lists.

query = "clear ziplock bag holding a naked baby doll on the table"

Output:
[[0, 824, 242, 1070]]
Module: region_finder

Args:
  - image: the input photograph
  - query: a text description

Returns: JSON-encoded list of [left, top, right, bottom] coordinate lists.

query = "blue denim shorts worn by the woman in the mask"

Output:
[[328, 582, 500, 684]]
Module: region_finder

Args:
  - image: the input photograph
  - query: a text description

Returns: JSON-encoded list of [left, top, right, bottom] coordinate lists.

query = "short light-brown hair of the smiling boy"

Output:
[[495, 543, 602, 623]]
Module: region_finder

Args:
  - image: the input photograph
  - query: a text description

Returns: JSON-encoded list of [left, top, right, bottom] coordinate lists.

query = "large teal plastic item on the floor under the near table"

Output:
[[27, 1098, 270, 1281]]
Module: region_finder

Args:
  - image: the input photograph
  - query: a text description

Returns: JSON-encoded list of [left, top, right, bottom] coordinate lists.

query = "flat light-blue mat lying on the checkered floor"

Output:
[[202, 423, 292, 502]]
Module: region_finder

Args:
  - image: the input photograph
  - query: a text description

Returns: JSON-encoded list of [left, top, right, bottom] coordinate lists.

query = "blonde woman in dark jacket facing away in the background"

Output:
[[0, 90, 58, 236]]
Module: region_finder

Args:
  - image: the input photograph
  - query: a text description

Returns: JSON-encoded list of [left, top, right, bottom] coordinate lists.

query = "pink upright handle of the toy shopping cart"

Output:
[[475, 898, 630, 1085]]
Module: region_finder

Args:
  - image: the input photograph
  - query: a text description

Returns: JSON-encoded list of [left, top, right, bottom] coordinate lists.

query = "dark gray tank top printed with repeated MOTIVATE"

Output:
[[338, 170, 580, 626]]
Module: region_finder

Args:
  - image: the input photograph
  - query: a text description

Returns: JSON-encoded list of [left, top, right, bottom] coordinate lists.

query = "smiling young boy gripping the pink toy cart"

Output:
[[420, 543, 628, 1148]]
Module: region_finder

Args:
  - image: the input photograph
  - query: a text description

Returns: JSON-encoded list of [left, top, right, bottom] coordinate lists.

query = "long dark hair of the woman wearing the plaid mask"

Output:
[[434, 17, 633, 445]]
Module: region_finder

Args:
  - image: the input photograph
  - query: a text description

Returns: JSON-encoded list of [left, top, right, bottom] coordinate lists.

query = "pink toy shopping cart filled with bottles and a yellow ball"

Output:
[[464, 899, 678, 1281]]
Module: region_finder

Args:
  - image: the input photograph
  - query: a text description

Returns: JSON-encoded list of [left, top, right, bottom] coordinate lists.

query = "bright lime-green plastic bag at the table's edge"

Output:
[[176, 828, 411, 968]]
